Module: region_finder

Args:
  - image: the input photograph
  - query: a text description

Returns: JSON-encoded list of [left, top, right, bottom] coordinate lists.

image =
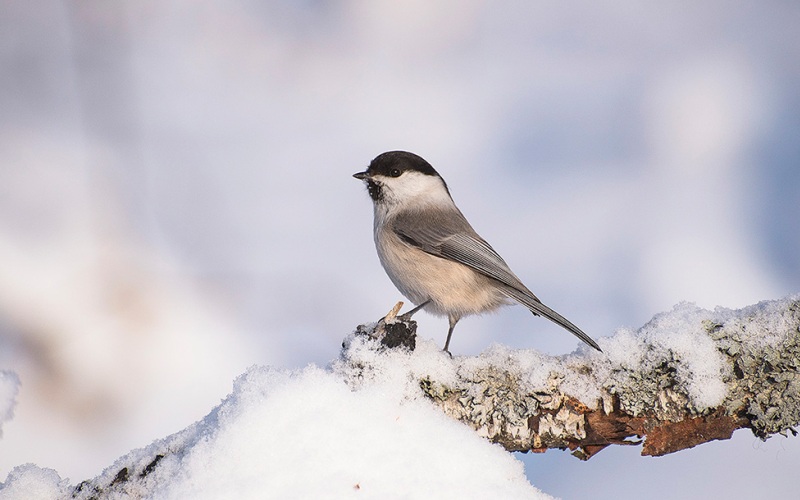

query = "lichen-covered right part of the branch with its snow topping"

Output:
[[344, 298, 800, 459]]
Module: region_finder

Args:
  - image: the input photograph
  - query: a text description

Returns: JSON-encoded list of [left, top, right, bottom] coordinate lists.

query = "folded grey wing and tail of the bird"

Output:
[[392, 212, 600, 351]]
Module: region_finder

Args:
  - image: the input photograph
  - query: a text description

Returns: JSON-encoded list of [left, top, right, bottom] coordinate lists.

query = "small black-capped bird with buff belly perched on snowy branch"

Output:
[[353, 151, 600, 353]]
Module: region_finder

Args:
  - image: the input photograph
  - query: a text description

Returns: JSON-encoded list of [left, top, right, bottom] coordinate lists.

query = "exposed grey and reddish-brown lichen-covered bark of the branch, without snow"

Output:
[[359, 297, 800, 460]]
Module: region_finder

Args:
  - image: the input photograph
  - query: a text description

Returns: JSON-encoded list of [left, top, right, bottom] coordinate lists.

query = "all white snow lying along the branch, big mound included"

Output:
[[0, 296, 800, 500]]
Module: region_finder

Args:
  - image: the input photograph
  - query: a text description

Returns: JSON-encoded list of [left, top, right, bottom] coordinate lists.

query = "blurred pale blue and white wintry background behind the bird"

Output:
[[0, 0, 800, 498]]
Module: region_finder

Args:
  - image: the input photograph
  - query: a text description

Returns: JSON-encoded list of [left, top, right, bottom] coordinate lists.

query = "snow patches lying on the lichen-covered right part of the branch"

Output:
[[428, 298, 764, 411]]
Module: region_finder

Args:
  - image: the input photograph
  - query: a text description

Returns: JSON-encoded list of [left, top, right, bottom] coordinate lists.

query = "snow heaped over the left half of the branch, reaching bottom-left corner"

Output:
[[0, 339, 551, 499]]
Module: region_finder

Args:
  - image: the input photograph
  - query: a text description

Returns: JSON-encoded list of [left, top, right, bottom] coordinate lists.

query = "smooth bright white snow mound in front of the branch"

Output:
[[151, 366, 541, 498]]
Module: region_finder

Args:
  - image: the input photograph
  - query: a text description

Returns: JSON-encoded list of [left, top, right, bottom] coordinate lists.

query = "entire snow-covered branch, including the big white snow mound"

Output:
[[6, 297, 800, 499]]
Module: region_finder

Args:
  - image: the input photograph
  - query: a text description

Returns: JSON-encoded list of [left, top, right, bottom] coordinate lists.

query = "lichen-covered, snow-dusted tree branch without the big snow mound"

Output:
[[62, 297, 800, 498]]
